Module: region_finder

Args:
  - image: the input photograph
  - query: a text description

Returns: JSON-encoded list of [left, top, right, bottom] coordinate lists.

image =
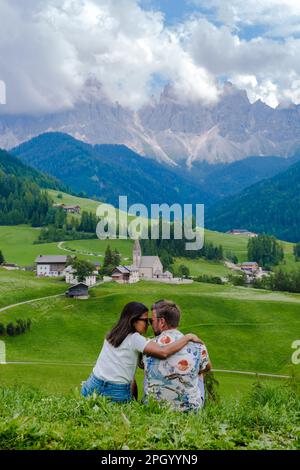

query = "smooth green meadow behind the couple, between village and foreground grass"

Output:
[[0, 271, 300, 398]]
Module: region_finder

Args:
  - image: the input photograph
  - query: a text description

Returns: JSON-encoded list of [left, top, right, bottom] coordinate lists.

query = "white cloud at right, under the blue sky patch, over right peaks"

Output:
[[181, 18, 300, 107]]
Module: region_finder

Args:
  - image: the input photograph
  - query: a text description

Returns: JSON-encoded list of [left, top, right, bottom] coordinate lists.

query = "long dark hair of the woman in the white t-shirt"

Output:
[[106, 302, 148, 348]]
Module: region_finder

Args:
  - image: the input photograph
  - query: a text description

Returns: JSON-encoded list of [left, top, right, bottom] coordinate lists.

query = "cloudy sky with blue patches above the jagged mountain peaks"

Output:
[[0, 0, 300, 113]]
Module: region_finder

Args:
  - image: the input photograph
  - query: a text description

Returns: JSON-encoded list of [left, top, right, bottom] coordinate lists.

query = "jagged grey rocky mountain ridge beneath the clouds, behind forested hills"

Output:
[[0, 83, 300, 167]]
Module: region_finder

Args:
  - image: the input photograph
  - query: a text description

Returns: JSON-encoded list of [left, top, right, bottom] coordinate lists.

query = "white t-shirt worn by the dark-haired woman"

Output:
[[93, 333, 149, 383]]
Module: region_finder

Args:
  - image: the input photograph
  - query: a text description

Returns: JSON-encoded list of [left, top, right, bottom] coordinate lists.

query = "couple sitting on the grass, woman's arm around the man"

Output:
[[82, 300, 211, 411]]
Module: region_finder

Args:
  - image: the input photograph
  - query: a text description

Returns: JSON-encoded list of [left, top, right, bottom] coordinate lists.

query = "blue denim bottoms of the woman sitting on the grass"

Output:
[[81, 374, 132, 403]]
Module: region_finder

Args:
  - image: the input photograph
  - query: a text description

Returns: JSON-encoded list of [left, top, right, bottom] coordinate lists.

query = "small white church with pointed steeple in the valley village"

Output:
[[112, 240, 173, 284]]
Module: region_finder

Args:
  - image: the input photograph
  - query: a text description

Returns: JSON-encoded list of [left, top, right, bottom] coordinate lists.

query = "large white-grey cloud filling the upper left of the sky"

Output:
[[0, 0, 217, 112]]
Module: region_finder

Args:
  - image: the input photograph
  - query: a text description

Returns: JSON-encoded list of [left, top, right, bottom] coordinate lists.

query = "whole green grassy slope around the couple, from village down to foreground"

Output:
[[0, 258, 300, 450]]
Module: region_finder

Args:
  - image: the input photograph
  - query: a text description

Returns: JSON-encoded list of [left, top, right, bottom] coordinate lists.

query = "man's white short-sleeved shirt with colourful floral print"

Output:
[[144, 329, 209, 411]]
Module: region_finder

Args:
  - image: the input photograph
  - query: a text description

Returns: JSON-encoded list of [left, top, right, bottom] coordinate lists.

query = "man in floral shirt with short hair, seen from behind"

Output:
[[143, 301, 211, 411]]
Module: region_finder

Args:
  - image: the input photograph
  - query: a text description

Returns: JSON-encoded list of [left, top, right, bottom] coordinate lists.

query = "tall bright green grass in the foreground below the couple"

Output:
[[0, 383, 300, 450]]
